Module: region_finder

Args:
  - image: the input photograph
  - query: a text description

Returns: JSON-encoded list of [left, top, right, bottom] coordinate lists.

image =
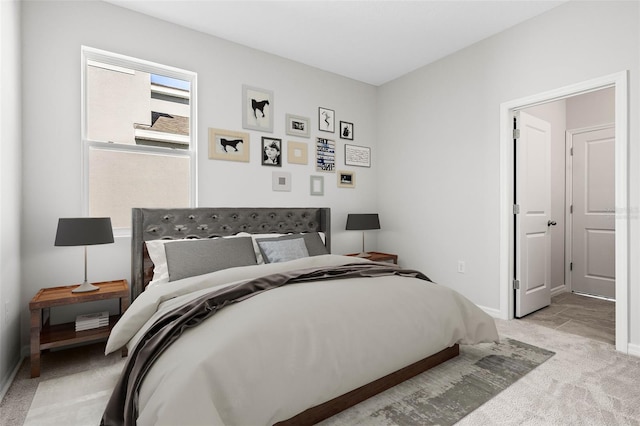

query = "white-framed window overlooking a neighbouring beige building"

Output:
[[82, 46, 197, 235]]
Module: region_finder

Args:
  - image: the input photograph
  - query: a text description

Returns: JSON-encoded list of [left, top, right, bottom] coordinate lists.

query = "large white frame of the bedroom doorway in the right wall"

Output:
[[499, 70, 630, 354]]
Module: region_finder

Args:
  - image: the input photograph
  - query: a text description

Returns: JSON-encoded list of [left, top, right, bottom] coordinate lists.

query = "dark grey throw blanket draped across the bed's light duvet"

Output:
[[100, 263, 430, 426]]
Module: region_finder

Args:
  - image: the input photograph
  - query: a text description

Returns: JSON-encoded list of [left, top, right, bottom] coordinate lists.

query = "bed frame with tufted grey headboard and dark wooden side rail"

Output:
[[131, 207, 460, 426]]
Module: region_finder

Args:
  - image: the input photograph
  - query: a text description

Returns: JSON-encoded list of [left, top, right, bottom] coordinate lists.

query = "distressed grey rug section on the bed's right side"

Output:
[[321, 338, 554, 426]]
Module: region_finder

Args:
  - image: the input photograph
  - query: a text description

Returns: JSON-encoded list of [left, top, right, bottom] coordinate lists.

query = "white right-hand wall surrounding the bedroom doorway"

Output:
[[377, 1, 640, 344]]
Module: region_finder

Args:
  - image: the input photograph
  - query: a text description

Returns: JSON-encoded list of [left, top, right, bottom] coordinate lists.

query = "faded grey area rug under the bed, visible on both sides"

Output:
[[24, 338, 554, 426]]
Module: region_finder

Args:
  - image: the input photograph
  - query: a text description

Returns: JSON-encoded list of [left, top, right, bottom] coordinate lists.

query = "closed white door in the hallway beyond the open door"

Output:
[[571, 126, 616, 299]]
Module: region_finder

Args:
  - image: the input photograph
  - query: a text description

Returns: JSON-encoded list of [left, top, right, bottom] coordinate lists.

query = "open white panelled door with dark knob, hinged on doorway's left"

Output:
[[514, 111, 552, 318]]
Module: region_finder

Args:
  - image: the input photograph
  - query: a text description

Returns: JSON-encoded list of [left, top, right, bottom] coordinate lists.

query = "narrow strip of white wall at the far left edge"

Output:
[[0, 1, 25, 392]]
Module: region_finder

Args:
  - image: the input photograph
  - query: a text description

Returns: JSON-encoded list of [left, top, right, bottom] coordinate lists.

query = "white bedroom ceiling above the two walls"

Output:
[[107, 0, 567, 86]]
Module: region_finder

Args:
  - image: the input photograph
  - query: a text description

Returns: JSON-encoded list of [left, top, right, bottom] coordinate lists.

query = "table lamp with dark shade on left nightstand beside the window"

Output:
[[55, 217, 113, 293]]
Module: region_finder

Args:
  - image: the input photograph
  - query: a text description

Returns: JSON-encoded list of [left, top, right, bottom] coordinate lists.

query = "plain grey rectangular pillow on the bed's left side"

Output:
[[165, 237, 257, 281]]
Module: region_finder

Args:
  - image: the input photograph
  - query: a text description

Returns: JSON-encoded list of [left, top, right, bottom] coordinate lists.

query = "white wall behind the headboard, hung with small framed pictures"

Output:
[[20, 1, 379, 345]]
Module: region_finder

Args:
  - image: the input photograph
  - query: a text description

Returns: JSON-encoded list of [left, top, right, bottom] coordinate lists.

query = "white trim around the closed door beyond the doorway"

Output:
[[564, 123, 615, 291]]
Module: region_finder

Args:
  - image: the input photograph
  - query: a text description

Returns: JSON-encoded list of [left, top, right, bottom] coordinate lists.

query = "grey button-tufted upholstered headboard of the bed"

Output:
[[131, 207, 331, 300]]
